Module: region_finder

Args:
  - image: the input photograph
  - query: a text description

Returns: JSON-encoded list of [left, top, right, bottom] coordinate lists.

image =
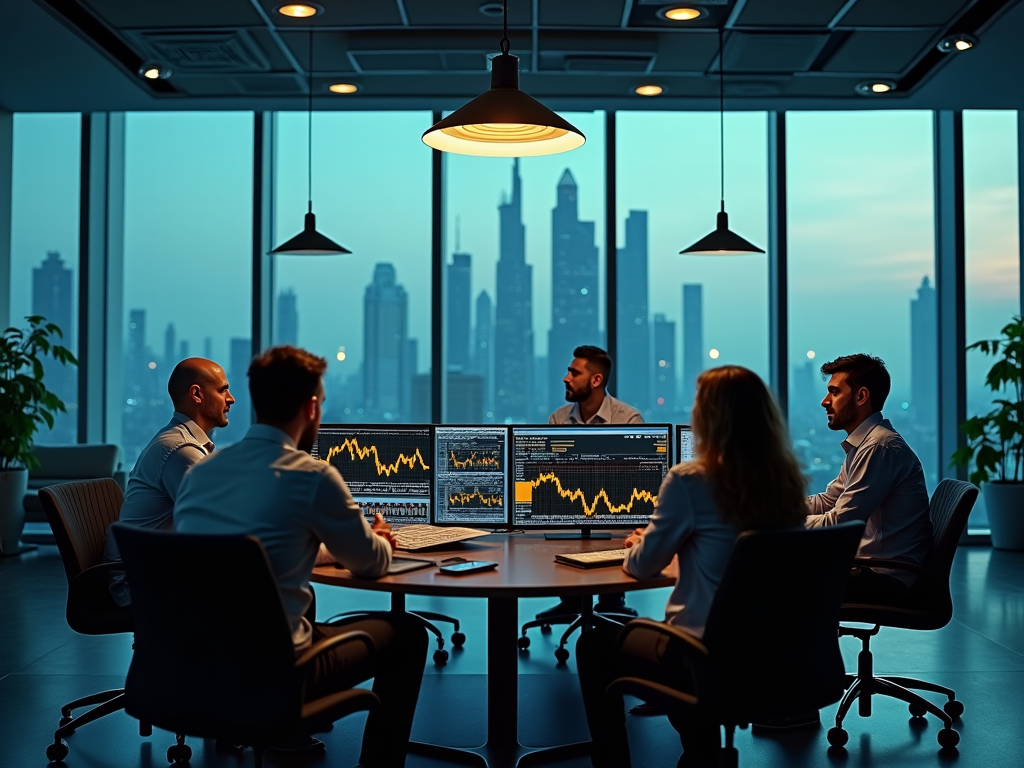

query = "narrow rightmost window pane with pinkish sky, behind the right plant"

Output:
[[964, 110, 1021, 529]]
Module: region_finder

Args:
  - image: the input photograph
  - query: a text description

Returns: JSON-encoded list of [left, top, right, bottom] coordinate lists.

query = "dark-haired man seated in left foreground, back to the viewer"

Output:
[[174, 346, 427, 768]]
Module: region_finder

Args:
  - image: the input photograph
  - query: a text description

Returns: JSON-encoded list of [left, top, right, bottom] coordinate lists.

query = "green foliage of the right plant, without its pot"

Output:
[[952, 315, 1024, 484]]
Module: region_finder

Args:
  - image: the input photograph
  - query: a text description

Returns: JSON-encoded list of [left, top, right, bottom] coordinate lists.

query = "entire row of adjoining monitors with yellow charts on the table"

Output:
[[312, 424, 693, 531]]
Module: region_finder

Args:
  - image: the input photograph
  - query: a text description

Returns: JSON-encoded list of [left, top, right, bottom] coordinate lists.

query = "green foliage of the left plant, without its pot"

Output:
[[0, 314, 78, 472]]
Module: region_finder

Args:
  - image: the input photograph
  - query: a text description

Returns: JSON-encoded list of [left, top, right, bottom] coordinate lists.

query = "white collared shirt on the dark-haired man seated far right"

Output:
[[807, 412, 932, 584]]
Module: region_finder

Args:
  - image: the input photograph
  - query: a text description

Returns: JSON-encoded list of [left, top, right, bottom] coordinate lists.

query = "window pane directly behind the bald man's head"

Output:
[[121, 112, 253, 467]]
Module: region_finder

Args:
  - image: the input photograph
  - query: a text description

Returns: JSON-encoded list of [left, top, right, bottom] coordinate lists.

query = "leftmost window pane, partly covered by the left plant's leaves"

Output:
[[10, 115, 82, 444]]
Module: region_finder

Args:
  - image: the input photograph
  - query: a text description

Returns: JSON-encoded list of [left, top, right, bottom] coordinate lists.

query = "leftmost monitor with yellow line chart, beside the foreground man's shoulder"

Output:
[[311, 424, 433, 525]]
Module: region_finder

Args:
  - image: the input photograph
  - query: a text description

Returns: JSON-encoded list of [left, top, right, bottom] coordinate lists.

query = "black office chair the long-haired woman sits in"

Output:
[[608, 522, 864, 768]]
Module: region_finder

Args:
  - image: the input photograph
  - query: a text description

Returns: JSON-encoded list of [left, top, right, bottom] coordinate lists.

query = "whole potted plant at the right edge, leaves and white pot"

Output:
[[952, 315, 1024, 550]]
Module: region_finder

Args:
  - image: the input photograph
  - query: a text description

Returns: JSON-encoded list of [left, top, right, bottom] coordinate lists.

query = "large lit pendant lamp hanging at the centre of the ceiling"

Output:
[[423, 0, 587, 158]]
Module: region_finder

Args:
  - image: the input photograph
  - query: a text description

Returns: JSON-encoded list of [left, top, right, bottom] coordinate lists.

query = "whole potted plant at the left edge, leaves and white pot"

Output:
[[0, 315, 78, 555]]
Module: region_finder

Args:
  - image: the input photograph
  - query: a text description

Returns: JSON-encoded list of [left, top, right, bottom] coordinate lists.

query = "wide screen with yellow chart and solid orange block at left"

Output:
[[512, 424, 670, 526]]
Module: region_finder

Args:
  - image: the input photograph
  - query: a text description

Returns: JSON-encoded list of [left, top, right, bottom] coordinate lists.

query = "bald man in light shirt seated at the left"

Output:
[[103, 357, 234, 606]]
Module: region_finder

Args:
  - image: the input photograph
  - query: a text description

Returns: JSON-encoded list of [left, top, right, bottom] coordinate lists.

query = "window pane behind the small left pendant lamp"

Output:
[[273, 112, 431, 422]]
